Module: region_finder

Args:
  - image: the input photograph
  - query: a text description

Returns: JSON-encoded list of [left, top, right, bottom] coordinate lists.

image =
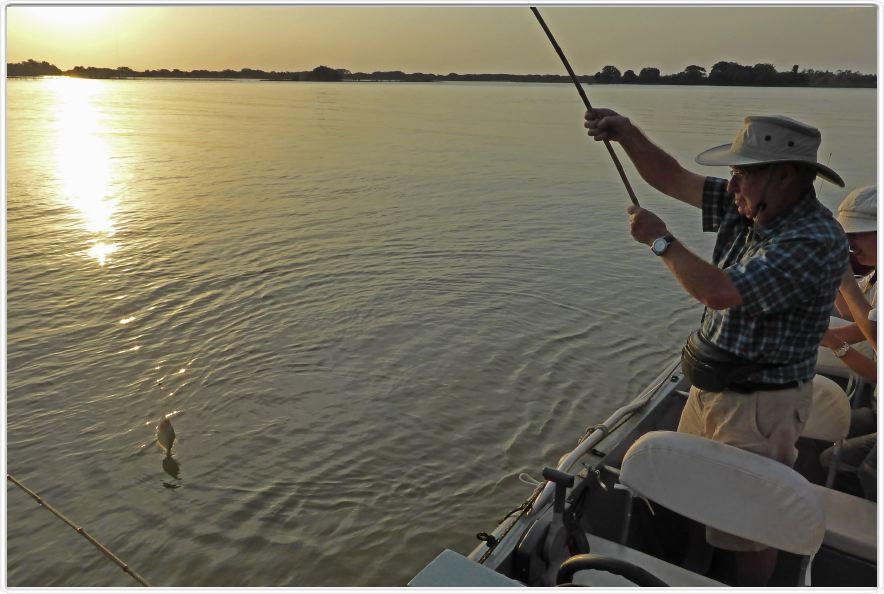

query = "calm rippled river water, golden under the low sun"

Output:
[[6, 79, 877, 586]]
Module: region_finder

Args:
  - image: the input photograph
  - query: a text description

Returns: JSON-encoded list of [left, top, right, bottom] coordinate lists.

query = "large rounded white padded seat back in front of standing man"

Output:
[[620, 431, 825, 555]]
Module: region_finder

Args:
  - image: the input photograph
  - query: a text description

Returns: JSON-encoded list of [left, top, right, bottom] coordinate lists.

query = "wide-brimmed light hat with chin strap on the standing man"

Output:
[[696, 116, 844, 188]]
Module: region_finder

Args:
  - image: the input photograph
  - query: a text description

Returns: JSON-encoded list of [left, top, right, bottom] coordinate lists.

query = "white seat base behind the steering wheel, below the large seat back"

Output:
[[574, 534, 727, 588]]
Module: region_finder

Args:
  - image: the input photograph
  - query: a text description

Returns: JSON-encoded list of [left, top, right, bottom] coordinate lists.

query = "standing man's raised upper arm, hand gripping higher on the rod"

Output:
[[584, 108, 706, 208]]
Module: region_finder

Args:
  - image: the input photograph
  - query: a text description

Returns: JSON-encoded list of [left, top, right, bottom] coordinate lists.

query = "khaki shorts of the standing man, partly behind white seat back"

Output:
[[678, 382, 813, 551]]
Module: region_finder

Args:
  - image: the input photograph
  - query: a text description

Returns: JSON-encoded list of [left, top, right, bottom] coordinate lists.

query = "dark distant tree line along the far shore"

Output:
[[6, 60, 878, 88]]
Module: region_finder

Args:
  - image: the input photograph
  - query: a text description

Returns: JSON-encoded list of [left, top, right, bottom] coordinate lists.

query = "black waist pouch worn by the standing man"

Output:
[[681, 330, 770, 392]]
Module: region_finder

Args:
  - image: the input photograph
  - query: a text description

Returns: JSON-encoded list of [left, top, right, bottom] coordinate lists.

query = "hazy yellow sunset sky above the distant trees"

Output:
[[6, 4, 878, 74]]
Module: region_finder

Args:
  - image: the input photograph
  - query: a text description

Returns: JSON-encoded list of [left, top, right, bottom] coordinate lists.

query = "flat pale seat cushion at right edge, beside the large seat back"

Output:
[[814, 485, 878, 563]]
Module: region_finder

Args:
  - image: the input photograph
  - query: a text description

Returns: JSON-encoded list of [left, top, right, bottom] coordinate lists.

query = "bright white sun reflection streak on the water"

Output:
[[46, 77, 119, 266]]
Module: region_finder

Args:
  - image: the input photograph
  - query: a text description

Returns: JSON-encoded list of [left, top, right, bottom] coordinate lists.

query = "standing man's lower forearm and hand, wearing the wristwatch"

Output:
[[627, 206, 742, 309]]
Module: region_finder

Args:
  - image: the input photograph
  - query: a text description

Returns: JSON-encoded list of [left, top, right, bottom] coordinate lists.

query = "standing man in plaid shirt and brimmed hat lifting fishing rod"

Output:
[[584, 109, 848, 586]]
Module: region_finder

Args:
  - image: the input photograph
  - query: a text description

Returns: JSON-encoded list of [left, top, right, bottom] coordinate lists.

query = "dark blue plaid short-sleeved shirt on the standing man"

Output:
[[701, 177, 849, 384]]
